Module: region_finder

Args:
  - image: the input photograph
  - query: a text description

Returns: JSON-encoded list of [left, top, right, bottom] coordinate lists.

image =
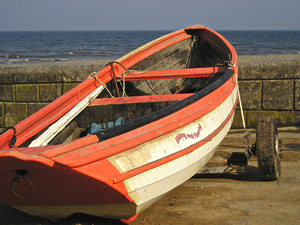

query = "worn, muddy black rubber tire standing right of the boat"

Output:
[[256, 117, 281, 181]]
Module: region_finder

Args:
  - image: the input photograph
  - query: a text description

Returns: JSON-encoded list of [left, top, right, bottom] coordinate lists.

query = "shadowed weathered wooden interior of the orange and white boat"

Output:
[[22, 32, 230, 147]]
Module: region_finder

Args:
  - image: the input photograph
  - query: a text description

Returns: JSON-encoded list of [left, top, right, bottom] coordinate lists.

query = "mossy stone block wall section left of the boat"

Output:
[[0, 60, 106, 129]]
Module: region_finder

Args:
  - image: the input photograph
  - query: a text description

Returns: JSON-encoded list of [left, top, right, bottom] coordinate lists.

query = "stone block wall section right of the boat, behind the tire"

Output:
[[233, 55, 300, 128]]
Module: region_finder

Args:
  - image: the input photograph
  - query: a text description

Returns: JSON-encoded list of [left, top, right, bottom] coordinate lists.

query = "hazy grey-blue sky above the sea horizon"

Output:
[[0, 0, 300, 31]]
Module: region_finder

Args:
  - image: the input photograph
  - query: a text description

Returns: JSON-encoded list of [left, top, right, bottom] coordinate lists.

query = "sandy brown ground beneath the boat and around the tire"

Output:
[[0, 127, 300, 225]]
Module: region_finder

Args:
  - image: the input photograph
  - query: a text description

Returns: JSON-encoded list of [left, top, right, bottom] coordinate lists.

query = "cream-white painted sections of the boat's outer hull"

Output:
[[7, 80, 237, 219]]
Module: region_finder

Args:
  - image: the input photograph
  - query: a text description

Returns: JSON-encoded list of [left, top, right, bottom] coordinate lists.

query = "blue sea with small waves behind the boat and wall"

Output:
[[0, 30, 300, 64]]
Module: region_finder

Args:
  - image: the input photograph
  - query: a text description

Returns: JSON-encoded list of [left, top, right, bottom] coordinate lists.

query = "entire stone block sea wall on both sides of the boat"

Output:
[[0, 55, 300, 129]]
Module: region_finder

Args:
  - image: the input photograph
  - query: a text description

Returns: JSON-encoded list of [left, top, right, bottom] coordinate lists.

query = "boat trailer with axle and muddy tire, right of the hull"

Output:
[[198, 117, 281, 181]]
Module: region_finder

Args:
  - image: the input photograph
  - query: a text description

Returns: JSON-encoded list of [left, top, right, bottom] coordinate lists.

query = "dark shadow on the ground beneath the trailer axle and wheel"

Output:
[[192, 165, 264, 182]]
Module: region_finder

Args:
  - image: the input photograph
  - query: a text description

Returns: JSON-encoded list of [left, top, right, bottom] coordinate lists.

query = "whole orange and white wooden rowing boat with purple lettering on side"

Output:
[[0, 25, 238, 222]]
